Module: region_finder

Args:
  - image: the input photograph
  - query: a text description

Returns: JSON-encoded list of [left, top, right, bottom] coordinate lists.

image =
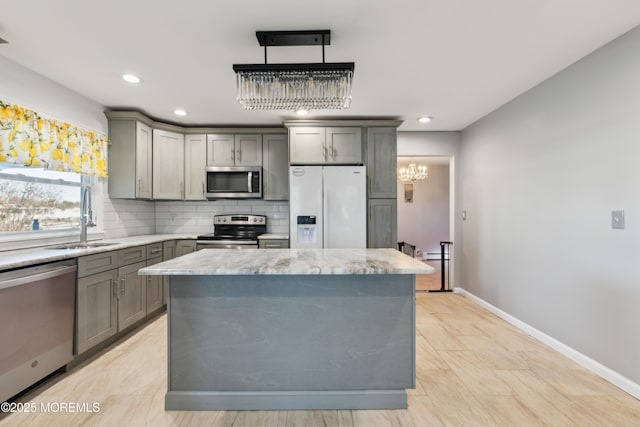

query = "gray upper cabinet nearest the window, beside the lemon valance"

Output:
[[109, 119, 153, 199]]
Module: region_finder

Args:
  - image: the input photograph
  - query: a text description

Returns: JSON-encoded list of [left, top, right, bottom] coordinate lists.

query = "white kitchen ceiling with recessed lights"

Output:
[[0, 0, 640, 130]]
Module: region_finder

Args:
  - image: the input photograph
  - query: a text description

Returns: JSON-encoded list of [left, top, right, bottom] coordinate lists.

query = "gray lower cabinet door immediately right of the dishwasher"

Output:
[[75, 270, 118, 354]]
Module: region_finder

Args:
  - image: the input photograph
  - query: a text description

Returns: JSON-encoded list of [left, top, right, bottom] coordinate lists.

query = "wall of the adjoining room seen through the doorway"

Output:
[[398, 162, 450, 259]]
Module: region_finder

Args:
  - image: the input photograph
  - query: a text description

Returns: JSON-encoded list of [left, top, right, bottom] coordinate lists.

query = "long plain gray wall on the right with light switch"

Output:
[[461, 28, 640, 383]]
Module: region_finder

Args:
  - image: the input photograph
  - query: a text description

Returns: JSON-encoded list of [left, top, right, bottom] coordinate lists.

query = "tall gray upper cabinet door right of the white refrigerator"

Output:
[[366, 127, 397, 199]]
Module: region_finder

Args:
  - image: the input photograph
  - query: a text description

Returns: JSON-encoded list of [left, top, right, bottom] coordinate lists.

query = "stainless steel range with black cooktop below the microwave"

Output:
[[196, 214, 267, 250]]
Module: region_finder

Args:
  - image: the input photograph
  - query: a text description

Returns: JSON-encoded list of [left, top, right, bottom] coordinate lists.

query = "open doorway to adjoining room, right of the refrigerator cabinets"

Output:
[[397, 156, 452, 292]]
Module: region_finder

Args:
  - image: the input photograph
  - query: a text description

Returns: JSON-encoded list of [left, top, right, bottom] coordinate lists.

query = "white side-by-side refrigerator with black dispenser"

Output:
[[289, 166, 367, 248]]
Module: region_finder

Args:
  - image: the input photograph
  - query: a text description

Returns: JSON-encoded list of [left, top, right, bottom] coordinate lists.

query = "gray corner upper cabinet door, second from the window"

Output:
[[153, 129, 184, 200]]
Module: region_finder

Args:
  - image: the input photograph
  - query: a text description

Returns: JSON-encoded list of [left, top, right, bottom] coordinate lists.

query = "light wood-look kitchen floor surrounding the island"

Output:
[[0, 294, 640, 427]]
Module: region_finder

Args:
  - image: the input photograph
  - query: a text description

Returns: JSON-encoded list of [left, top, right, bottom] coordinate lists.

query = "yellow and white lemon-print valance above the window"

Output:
[[0, 100, 107, 177]]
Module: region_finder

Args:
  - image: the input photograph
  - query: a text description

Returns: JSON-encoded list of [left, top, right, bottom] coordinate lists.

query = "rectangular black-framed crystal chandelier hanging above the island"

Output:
[[233, 30, 354, 110]]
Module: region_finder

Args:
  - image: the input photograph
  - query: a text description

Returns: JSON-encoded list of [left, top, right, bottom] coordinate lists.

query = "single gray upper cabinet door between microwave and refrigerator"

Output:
[[262, 134, 289, 200]]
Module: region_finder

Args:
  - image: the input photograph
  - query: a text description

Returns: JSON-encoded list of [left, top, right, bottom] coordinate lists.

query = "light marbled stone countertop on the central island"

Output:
[[138, 248, 435, 276]]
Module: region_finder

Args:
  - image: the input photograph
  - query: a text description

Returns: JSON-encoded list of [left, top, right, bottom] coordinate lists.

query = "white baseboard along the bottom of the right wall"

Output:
[[453, 287, 640, 399]]
